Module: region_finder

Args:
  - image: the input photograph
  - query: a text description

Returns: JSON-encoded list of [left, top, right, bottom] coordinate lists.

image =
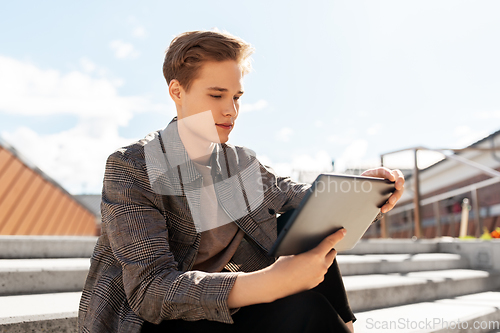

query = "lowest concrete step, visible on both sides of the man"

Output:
[[0, 291, 500, 333]]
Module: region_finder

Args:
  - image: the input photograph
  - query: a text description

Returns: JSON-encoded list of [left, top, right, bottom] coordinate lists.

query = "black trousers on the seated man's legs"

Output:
[[141, 260, 355, 333]]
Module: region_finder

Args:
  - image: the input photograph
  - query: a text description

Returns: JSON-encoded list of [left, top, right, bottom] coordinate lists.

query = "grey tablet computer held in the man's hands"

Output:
[[269, 174, 395, 257]]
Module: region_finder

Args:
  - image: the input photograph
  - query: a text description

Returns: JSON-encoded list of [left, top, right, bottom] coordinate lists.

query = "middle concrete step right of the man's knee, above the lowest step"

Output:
[[344, 269, 500, 311]]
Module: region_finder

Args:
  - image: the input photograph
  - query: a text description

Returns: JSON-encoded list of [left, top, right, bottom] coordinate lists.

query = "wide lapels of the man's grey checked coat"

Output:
[[159, 118, 273, 250]]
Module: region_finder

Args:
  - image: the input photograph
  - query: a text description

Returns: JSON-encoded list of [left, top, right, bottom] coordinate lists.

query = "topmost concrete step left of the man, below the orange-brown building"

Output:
[[0, 236, 97, 259]]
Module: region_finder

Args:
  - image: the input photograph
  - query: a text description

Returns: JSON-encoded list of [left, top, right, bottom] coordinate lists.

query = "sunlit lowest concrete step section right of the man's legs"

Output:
[[354, 291, 500, 333]]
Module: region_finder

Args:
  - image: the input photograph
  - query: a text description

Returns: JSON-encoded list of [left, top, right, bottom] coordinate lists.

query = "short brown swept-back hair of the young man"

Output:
[[163, 31, 254, 90]]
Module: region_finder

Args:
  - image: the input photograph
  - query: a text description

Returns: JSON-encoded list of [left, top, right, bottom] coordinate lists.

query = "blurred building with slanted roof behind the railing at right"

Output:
[[365, 131, 500, 238]]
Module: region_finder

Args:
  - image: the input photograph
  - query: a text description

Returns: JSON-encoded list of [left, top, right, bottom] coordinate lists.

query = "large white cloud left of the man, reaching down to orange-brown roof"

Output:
[[0, 56, 170, 193]]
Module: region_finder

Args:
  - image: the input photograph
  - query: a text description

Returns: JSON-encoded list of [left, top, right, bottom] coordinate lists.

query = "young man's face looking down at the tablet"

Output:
[[177, 60, 243, 143]]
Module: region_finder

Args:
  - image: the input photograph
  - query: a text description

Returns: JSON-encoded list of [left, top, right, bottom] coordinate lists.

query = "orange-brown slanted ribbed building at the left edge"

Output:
[[0, 136, 99, 235]]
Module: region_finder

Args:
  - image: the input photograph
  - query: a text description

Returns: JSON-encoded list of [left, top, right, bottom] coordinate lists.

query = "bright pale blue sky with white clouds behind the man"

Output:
[[0, 0, 500, 194]]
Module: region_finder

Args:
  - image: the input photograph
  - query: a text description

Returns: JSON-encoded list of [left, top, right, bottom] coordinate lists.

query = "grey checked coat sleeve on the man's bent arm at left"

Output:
[[101, 151, 238, 323]]
